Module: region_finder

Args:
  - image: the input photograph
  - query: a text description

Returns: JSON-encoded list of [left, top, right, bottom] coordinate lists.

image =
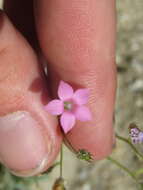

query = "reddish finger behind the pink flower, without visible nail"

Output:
[[35, 0, 116, 159]]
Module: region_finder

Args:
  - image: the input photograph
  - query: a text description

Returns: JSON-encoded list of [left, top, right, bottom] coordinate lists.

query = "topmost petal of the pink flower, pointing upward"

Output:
[[58, 81, 73, 100]]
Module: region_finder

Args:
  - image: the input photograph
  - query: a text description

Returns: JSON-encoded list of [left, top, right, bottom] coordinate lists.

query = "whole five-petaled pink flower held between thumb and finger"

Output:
[[45, 81, 91, 133]]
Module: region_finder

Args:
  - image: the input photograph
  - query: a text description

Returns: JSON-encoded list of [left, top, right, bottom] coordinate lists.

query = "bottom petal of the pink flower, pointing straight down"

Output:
[[60, 112, 75, 133]]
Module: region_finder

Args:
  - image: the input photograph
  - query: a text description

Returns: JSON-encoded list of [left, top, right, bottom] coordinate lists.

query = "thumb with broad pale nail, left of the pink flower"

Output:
[[0, 10, 61, 176]]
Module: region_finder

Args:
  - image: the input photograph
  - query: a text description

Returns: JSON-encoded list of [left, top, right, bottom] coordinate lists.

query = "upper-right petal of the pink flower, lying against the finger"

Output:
[[73, 89, 89, 105]]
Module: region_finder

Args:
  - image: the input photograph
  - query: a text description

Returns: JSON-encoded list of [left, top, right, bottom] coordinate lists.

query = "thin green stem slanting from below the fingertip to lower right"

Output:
[[107, 156, 138, 182]]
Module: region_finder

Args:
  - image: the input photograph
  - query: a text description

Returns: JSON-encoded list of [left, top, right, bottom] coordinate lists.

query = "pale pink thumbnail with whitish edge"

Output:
[[0, 111, 51, 176]]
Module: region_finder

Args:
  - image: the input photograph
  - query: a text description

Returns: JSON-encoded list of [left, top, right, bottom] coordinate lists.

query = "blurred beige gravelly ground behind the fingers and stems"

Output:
[[0, 0, 143, 190]]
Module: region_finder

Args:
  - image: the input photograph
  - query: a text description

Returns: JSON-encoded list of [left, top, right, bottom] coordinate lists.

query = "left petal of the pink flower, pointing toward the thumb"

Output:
[[45, 99, 64, 115]]
